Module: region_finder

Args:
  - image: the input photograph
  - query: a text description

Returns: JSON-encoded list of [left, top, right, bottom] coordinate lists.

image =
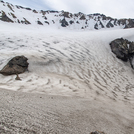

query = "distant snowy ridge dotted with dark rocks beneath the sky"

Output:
[[0, 1, 134, 30]]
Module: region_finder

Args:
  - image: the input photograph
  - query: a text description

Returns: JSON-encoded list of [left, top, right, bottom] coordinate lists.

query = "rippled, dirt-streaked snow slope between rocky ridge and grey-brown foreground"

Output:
[[0, 22, 134, 103]]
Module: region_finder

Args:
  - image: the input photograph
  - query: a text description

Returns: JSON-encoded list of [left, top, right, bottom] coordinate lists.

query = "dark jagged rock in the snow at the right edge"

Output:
[[110, 38, 134, 68]]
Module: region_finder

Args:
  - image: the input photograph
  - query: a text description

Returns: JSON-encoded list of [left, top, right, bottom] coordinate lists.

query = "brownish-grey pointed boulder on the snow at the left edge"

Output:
[[0, 56, 29, 75]]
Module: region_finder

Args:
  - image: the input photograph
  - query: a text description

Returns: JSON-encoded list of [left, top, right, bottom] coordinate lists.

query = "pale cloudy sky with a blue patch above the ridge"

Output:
[[4, 0, 134, 18]]
